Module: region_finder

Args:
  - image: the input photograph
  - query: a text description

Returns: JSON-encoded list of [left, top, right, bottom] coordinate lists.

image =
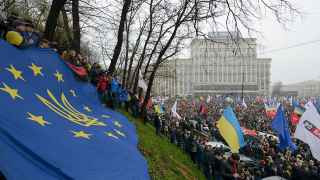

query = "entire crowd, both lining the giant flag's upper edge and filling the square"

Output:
[[0, 14, 320, 180]]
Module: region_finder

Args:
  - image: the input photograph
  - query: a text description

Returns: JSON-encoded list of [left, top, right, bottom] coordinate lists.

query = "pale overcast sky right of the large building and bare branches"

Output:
[[257, 0, 320, 84]]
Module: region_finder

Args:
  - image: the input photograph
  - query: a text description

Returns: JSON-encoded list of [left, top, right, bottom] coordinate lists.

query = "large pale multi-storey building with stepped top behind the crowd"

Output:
[[154, 33, 271, 96]]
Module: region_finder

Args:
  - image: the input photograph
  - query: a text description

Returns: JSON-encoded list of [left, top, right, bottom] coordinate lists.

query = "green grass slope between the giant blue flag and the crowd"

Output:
[[121, 111, 205, 180]]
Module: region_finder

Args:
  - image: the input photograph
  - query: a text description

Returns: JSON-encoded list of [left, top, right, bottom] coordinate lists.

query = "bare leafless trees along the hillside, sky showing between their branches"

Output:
[[0, 0, 299, 113]]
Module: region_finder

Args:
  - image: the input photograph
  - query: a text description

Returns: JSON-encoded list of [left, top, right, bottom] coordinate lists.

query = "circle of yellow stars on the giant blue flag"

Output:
[[0, 63, 126, 139]]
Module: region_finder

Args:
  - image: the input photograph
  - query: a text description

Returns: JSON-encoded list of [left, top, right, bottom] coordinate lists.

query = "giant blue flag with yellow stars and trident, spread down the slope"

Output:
[[0, 40, 149, 180]]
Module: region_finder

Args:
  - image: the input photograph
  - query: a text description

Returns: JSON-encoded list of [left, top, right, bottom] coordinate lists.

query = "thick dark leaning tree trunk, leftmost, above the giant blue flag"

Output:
[[44, 0, 67, 41]]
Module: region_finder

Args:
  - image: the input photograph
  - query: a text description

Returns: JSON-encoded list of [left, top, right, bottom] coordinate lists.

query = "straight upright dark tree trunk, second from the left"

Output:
[[72, 0, 81, 53]]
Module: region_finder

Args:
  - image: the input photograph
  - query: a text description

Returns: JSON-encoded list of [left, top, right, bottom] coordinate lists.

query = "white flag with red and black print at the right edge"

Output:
[[294, 102, 320, 161]]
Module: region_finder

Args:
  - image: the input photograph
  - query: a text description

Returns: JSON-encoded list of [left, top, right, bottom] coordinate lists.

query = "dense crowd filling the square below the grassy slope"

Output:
[[150, 97, 320, 180]]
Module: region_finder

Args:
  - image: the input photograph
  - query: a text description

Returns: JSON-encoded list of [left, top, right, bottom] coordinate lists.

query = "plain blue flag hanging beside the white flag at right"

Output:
[[271, 105, 297, 151]]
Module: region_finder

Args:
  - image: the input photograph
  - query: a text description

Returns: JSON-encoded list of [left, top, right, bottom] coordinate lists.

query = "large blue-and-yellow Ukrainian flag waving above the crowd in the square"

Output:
[[217, 106, 245, 152]]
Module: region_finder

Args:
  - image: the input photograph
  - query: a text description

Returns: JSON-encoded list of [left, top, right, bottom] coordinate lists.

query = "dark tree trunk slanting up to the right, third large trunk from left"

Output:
[[108, 0, 131, 75]]
